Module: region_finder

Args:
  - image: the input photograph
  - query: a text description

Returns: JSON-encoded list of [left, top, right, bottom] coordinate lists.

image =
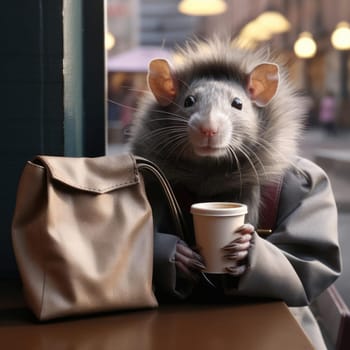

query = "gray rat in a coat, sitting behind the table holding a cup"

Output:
[[130, 38, 341, 349]]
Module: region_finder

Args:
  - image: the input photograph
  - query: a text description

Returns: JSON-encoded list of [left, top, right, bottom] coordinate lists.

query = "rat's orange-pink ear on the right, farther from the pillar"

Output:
[[247, 63, 279, 107]]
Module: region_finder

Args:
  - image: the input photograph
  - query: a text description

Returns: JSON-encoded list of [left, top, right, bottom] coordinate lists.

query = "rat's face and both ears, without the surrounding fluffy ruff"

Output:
[[148, 59, 279, 158]]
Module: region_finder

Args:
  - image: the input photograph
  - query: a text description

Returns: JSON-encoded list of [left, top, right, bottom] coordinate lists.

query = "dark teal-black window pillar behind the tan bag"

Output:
[[0, 0, 107, 278]]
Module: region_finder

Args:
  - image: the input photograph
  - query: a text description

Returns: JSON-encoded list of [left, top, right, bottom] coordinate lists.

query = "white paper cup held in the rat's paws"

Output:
[[191, 202, 248, 273]]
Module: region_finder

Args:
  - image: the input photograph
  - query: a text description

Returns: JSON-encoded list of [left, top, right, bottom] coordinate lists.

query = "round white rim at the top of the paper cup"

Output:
[[191, 202, 248, 216]]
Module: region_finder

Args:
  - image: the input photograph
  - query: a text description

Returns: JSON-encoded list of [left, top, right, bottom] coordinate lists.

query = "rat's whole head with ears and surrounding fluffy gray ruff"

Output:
[[131, 40, 305, 179]]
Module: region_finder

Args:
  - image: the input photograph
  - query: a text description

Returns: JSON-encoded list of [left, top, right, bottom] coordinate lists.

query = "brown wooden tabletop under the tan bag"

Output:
[[0, 282, 313, 350]]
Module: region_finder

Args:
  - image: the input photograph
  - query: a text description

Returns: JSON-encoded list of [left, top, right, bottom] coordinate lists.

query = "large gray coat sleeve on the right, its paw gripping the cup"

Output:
[[226, 159, 341, 306]]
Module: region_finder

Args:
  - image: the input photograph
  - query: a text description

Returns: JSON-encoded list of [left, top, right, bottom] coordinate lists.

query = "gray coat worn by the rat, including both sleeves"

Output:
[[154, 158, 341, 349]]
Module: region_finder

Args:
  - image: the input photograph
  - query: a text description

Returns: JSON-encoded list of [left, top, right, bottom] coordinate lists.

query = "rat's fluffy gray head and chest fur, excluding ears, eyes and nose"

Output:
[[131, 39, 305, 225]]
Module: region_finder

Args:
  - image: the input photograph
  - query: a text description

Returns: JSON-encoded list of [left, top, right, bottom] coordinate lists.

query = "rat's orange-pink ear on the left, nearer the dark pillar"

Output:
[[147, 59, 177, 106]]
